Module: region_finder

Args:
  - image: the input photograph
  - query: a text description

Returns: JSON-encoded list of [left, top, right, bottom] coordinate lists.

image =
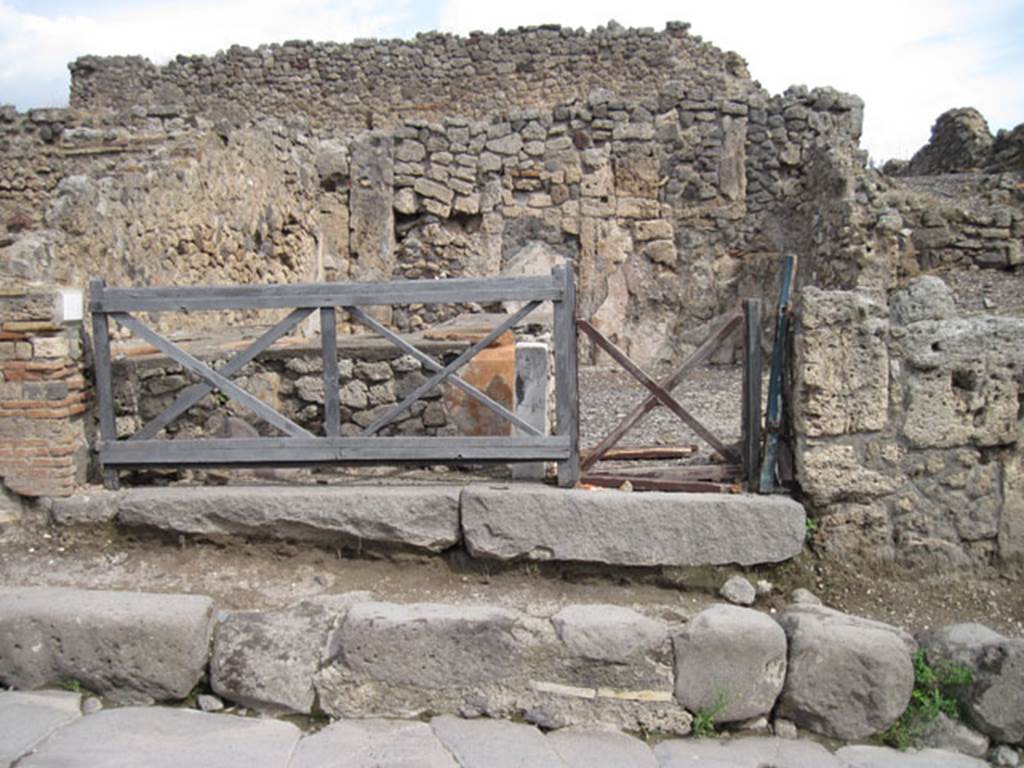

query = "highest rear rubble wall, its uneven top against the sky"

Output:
[[70, 23, 750, 136]]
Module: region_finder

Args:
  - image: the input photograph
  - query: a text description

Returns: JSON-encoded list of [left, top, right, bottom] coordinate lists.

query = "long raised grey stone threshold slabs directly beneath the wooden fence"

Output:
[[52, 482, 806, 567]]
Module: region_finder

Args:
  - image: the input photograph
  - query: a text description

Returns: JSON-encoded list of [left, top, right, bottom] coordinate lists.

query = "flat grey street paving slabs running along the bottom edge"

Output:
[[0, 691, 988, 768]]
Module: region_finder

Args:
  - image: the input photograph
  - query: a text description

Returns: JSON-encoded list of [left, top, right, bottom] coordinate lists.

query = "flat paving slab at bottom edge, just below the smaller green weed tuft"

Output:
[[654, 737, 845, 768]]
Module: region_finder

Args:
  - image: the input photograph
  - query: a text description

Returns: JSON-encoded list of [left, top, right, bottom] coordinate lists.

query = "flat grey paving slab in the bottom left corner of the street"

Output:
[[0, 691, 82, 768]]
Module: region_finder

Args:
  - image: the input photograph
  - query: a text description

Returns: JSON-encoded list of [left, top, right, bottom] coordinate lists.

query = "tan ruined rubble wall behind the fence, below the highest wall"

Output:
[[0, 72, 862, 361]]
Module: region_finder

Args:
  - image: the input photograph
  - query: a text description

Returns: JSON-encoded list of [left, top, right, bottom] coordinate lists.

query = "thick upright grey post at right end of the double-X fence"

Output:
[[552, 262, 580, 487]]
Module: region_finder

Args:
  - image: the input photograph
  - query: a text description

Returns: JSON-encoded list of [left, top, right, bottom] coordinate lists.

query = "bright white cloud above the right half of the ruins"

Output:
[[440, 0, 1024, 159]]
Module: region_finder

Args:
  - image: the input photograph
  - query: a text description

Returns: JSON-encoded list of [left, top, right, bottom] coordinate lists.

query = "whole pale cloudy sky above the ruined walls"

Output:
[[0, 0, 1024, 162]]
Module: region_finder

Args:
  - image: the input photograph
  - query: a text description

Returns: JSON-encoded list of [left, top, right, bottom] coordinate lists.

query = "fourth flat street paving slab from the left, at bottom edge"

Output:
[[430, 716, 566, 768]]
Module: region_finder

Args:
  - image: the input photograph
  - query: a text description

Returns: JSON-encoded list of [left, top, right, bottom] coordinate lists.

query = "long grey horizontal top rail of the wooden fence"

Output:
[[90, 275, 562, 312]]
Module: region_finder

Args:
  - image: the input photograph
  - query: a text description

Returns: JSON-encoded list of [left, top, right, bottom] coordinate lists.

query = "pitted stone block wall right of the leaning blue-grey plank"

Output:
[[794, 276, 1024, 568]]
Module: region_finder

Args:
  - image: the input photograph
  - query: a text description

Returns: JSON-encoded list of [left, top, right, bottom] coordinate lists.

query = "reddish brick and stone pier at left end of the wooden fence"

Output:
[[0, 287, 90, 497]]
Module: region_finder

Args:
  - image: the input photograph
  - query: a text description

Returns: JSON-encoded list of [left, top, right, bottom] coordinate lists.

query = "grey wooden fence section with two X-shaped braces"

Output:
[[89, 266, 580, 485]]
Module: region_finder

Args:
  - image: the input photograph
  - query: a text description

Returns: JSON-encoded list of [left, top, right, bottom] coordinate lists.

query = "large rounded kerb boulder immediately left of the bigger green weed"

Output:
[[776, 605, 916, 740]]
